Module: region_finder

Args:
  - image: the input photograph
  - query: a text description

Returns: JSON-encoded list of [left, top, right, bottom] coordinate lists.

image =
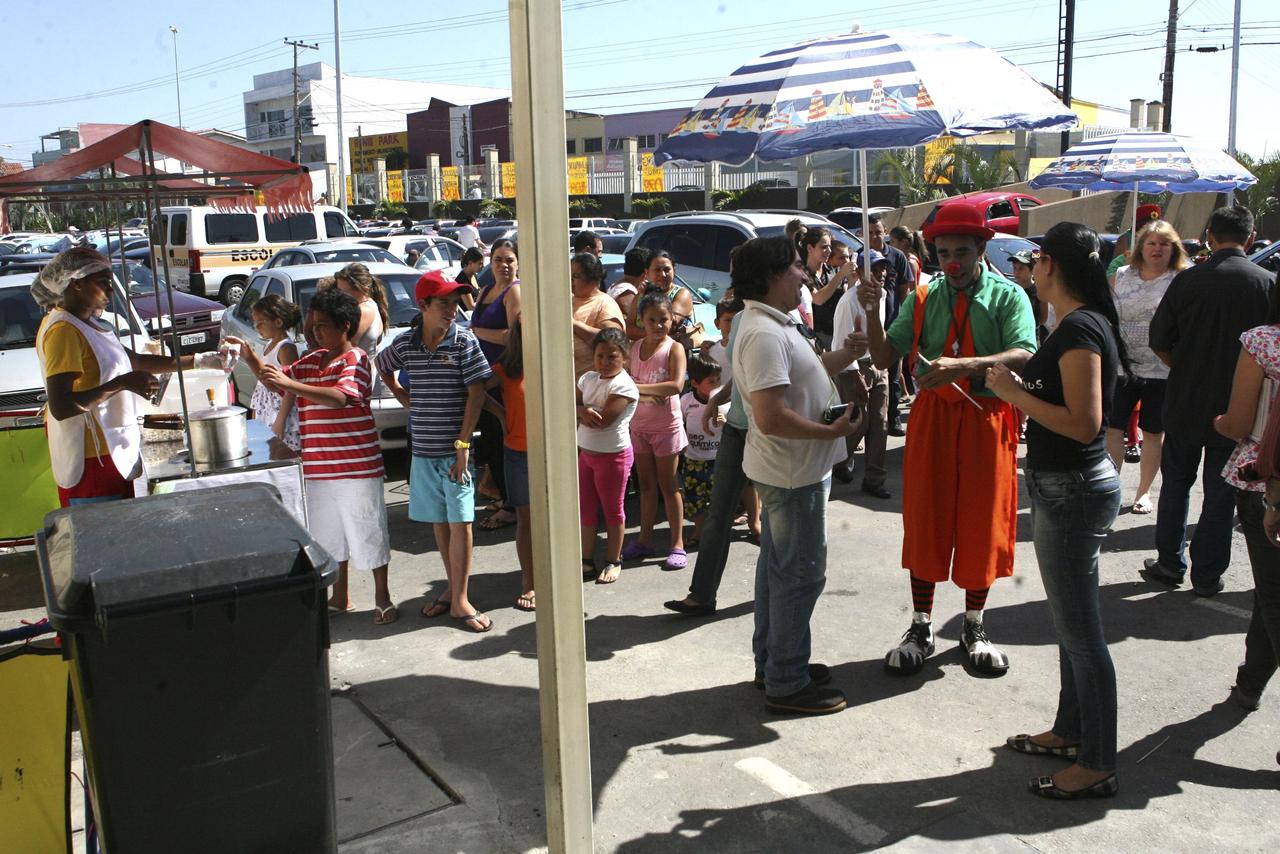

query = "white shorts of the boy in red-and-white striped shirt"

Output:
[[307, 478, 392, 572]]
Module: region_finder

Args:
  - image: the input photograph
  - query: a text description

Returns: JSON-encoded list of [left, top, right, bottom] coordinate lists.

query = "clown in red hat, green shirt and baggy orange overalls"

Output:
[[858, 205, 1036, 676]]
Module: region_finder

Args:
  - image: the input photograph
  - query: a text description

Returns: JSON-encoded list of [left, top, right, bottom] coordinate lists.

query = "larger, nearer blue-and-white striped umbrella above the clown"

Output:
[[654, 31, 1076, 165]]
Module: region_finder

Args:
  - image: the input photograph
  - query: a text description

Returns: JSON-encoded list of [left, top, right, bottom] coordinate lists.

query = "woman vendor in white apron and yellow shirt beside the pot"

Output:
[[31, 247, 209, 507]]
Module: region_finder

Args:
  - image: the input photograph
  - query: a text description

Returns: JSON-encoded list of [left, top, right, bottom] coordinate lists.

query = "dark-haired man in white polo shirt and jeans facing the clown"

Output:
[[731, 237, 867, 714]]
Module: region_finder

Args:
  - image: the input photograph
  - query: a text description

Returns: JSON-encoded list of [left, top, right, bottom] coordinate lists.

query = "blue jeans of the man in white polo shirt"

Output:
[[751, 474, 831, 697]]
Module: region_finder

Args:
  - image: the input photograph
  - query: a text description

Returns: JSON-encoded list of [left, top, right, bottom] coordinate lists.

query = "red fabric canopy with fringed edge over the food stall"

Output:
[[0, 119, 311, 234]]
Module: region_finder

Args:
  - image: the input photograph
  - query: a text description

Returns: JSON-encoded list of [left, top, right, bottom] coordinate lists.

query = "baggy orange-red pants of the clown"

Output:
[[902, 389, 1018, 590]]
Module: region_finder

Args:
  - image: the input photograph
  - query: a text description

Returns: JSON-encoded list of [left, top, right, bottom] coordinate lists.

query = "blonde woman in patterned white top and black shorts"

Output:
[[1107, 219, 1189, 513]]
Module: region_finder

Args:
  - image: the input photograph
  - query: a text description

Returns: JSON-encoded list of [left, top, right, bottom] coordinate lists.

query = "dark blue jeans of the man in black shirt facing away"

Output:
[[1156, 430, 1235, 589]]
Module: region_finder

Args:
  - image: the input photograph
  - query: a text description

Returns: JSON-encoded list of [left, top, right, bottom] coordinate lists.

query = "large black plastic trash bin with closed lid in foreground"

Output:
[[36, 484, 337, 854]]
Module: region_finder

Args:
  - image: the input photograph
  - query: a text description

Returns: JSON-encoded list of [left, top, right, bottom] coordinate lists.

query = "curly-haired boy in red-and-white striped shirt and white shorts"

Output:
[[228, 288, 399, 625]]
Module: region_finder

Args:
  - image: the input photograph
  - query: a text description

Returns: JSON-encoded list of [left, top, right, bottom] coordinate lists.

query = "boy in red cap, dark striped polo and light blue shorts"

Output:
[[376, 271, 493, 632]]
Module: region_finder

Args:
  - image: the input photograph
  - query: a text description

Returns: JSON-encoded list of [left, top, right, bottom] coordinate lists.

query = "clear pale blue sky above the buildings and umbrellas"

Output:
[[0, 0, 1280, 160]]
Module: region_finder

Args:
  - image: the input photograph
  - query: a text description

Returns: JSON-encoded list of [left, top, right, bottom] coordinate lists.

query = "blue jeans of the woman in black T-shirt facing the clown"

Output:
[[1027, 460, 1120, 771]]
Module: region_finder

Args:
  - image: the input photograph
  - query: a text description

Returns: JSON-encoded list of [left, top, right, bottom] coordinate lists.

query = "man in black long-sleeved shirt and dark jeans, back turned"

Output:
[[1144, 207, 1275, 597]]
